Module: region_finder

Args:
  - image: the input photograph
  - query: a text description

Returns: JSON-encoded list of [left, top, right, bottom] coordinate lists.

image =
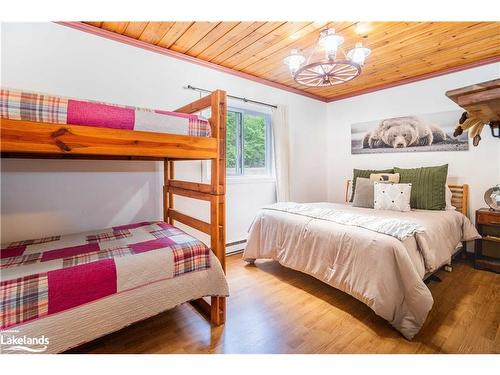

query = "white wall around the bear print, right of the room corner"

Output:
[[327, 63, 500, 220]]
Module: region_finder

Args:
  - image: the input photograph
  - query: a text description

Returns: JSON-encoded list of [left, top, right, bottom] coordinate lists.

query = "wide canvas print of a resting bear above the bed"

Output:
[[351, 111, 469, 154]]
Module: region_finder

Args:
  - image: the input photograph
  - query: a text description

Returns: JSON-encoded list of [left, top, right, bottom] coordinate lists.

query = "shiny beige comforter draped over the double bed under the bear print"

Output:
[[243, 203, 479, 339]]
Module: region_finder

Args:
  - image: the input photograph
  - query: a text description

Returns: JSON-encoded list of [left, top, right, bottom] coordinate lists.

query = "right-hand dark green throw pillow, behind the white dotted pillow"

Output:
[[394, 164, 448, 210]]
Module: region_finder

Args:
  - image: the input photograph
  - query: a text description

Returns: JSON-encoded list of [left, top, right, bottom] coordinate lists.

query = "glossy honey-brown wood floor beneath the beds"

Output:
[[71, 255, 500, 353]]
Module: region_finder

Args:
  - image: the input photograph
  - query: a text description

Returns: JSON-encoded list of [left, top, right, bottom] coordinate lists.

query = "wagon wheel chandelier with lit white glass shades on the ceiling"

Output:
[[283, 28, 371, 87]]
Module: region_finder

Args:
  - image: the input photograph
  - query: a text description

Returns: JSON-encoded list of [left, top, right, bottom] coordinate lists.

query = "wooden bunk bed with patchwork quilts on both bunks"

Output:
[[0, 89, 228, 352]]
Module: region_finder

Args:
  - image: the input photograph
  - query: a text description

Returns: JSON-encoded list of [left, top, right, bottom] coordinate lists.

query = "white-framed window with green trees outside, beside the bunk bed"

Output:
[[226, 108, 272, 176]]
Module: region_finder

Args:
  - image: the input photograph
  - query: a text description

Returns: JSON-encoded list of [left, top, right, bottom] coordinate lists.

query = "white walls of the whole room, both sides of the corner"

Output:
[[1, 23, 500, 242]]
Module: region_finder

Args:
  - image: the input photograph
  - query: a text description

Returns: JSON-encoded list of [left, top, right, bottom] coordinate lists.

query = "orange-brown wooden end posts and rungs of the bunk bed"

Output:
[[167, 90, 227, 325]]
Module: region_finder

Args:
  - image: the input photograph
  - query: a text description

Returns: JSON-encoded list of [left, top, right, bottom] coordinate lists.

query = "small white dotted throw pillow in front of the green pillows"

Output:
[[373, 182, 411, 212]]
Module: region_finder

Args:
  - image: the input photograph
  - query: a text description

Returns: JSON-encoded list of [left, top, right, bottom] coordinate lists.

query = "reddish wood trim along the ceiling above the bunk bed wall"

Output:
[[54, 21, 327, 103]]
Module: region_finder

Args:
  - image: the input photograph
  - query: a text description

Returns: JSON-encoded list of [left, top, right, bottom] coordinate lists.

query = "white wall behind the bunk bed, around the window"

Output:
[[1, 23, 327, 242]]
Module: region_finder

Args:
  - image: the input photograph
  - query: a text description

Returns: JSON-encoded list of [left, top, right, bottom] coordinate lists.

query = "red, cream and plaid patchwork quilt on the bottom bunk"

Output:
[[0, 221, 210, 329]]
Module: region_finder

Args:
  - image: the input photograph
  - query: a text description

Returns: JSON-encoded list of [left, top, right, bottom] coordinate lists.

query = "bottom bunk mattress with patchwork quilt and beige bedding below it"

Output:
[[0, 222, 229, 352]]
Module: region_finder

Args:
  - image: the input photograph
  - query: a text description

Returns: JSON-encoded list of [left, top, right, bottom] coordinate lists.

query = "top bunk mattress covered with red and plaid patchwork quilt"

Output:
[[0, 88, 211, 137]]
